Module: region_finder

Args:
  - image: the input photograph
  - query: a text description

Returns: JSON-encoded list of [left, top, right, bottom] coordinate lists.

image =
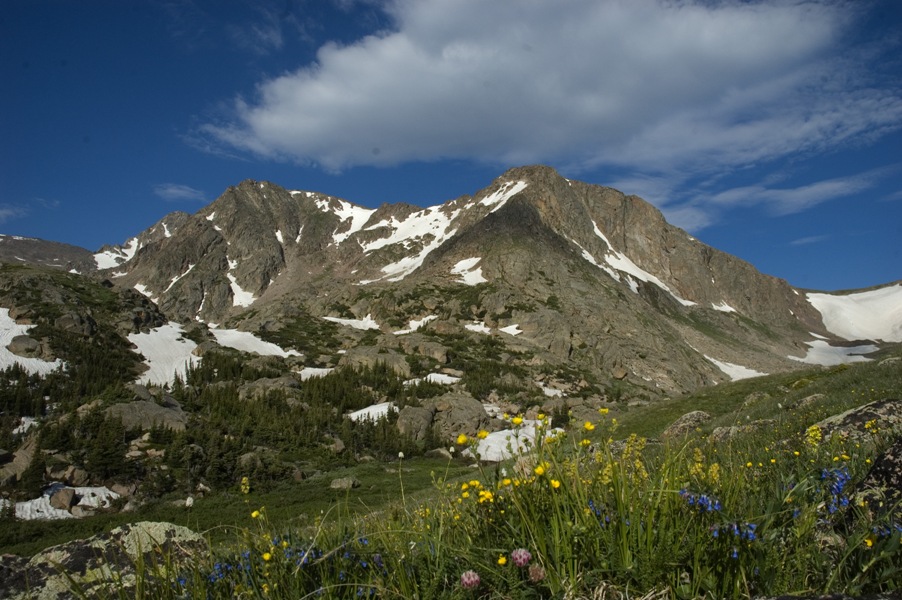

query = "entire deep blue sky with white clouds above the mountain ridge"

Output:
[[0, 0, 902, 290]]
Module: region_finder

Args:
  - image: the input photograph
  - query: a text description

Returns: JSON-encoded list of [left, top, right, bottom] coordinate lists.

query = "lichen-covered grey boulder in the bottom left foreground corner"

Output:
[[0, 521, 209, 600]]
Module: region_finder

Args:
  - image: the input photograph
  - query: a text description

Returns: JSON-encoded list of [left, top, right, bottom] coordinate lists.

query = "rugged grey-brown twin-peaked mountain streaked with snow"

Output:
[[63, 166, 848, 395]]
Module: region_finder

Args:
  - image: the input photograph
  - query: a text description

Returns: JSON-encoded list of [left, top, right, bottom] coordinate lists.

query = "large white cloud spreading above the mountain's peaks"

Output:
[[202, 0, 902, 178]]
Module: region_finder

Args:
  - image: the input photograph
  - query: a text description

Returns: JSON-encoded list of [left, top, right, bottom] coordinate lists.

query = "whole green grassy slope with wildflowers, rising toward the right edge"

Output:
[[7, 350, 902, 599]]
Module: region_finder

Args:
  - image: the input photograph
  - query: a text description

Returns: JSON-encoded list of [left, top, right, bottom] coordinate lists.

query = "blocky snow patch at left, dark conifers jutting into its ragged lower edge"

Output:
[[128, 323, 200, 385]]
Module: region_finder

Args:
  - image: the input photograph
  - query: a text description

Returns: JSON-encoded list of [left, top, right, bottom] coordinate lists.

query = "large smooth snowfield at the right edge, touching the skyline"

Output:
[[806, 284, 902, 342]]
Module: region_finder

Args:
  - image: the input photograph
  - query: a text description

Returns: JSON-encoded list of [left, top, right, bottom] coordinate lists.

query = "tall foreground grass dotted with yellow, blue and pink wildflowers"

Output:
[[109, 411, 902, 600]]
